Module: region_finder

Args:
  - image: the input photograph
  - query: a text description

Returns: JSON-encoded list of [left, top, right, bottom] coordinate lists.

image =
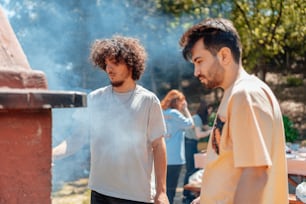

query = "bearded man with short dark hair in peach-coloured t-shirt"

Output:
[[180, 18, 288, 204]]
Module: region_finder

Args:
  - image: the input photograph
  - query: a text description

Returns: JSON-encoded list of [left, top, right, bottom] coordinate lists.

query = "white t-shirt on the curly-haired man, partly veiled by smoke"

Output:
[[69, 85, 166, 202]]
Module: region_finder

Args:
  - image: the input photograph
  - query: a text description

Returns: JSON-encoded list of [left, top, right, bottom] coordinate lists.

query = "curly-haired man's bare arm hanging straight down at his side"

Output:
[[152, 137, 169, 204]]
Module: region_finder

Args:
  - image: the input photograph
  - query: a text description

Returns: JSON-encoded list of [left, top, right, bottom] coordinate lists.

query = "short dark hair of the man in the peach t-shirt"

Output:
[[179, 18, 242, 64]]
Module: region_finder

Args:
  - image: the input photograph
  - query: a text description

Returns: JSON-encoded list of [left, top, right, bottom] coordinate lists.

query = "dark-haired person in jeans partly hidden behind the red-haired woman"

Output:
[[183, 100, 211, 204]]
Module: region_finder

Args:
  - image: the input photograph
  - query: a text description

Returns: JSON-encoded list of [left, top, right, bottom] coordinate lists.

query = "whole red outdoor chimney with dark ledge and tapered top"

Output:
[[0, 7, 86, 204]]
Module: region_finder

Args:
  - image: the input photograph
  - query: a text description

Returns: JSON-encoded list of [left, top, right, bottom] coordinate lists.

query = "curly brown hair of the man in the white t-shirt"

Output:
[[89, 35, 147, 80]]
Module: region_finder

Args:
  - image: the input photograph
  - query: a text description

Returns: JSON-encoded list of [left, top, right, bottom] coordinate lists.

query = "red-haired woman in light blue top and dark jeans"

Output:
[[161, 89, 193, 204]]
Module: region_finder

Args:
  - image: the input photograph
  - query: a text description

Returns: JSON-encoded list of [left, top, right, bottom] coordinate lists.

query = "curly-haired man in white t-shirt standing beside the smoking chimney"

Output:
[[53, 36, 169, 204]]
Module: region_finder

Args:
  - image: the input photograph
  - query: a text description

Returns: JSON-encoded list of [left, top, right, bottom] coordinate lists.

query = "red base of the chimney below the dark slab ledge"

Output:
[[0, 109, 51, 204]]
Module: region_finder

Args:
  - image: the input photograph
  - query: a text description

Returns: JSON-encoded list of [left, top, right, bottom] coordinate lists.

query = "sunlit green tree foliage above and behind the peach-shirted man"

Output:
[[155, 0, 306, 80]]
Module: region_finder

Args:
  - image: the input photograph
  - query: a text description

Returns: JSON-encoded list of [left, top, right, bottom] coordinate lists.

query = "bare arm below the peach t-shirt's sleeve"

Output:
[[234, 166, 268, 204]]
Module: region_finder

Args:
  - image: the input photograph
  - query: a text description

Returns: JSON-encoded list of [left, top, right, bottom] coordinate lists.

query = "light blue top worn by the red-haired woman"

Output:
[[163, 109, 192, 165]]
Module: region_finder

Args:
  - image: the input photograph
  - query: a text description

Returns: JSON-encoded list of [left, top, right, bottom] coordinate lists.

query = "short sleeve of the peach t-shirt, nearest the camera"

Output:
[[228, 91, 272, 167]]
